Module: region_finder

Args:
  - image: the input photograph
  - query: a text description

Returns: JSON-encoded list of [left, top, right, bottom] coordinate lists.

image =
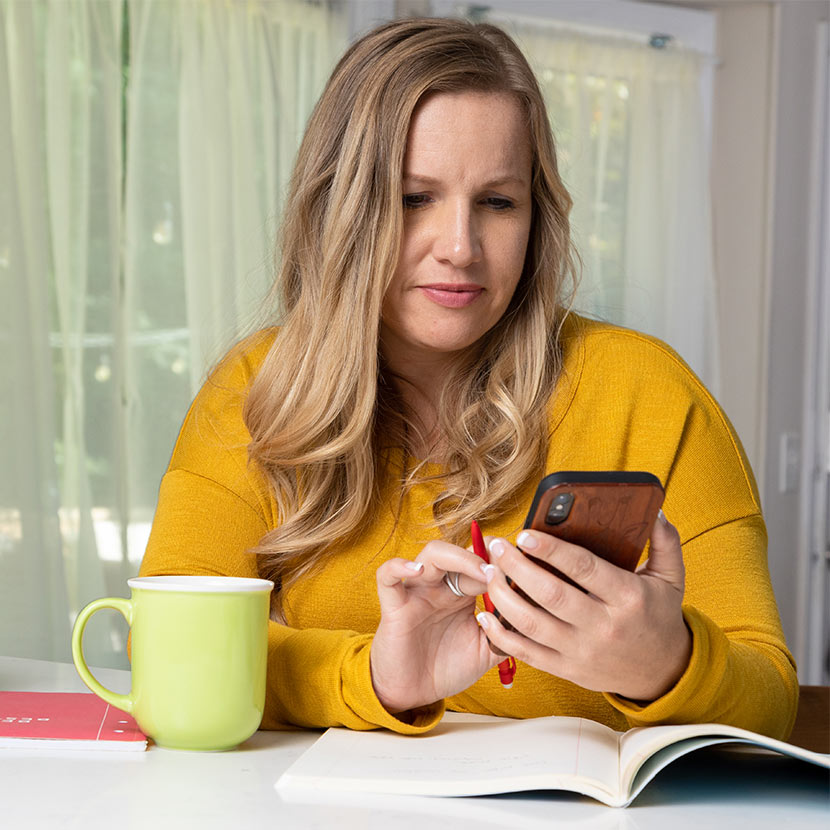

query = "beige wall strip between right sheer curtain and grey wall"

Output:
[[711, 3, 773, 486]]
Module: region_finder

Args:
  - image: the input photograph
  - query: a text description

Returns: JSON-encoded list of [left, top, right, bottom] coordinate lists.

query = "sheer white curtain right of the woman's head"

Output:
[[490, 16, 719, 394]]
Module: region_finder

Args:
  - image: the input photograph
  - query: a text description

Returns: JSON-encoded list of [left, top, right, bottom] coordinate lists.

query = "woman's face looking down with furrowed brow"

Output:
[[381, 92, 532, 374]]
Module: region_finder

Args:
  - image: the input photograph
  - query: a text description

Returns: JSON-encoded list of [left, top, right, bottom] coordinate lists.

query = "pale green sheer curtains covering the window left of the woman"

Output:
[[0, 0, 346, 666]]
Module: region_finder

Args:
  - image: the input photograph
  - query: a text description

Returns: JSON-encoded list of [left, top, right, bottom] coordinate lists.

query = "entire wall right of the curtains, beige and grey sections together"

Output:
[[653, 0, 830, 668]]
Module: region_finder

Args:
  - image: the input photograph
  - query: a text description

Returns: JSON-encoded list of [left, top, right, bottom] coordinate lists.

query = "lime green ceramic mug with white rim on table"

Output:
[[72, 576, 274, 750]]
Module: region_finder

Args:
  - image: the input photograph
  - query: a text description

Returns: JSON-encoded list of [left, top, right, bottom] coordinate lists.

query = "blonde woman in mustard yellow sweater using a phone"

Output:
[[141, 20, 798, 737]]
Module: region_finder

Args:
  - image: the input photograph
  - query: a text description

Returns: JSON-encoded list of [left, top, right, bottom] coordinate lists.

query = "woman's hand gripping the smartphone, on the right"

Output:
[[479, 515, 692, 701]]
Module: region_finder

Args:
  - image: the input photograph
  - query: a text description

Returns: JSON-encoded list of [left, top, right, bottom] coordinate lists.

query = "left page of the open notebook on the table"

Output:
[[278, 714, 619, 800]]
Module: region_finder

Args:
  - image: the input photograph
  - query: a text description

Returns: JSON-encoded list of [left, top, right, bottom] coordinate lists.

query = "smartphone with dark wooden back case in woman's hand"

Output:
[[496, 470, 665, 629]]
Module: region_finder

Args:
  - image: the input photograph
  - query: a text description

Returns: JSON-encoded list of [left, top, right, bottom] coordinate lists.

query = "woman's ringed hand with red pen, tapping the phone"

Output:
[[371, 541, 500, 714]]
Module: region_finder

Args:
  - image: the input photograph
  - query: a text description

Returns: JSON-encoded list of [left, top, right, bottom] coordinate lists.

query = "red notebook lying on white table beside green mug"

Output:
[[0, 692, 147, 751]]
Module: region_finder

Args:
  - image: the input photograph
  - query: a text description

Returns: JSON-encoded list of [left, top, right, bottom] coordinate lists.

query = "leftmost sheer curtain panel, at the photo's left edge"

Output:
[[0, 0, 121, 659]]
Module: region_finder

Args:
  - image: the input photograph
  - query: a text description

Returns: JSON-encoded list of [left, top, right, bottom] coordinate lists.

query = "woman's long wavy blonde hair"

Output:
[[244, 18, 576, 607]]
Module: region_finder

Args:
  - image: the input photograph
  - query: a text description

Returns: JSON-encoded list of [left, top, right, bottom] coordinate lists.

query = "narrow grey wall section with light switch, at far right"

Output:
[[763, 0, 830, 682]]
